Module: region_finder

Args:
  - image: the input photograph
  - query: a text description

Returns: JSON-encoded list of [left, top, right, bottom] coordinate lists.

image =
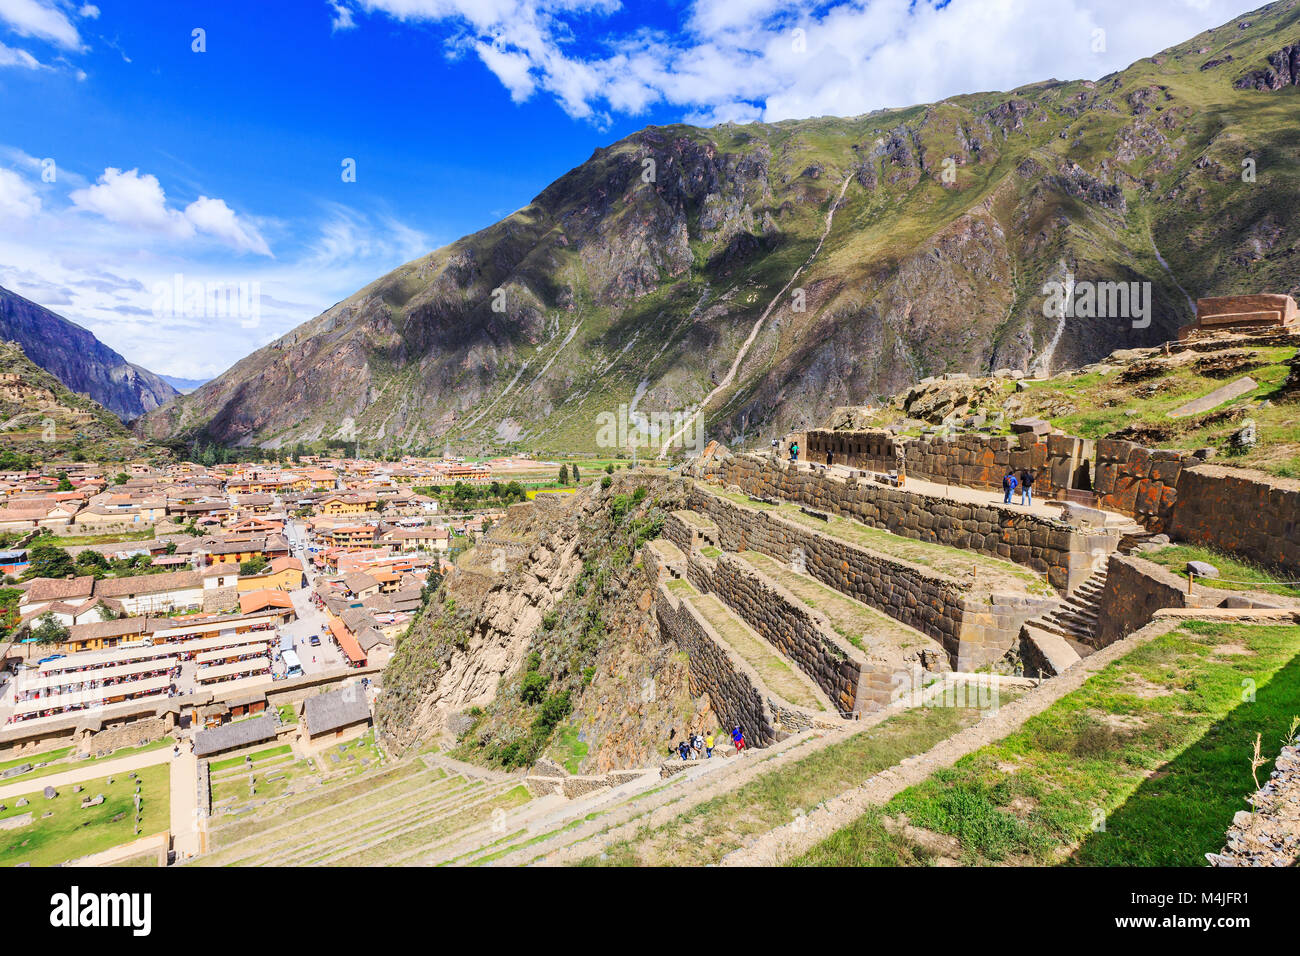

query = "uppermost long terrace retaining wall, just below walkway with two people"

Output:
[[722, 455, 1118, 595]]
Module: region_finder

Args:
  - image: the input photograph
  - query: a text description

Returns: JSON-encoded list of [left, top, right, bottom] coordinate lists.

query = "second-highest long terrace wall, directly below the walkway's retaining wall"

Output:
[[692, 492, 1056, 670]]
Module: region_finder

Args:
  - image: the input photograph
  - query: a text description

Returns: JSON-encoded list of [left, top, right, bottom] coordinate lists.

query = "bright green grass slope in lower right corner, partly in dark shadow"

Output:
[[793, 622, 1300, 866]]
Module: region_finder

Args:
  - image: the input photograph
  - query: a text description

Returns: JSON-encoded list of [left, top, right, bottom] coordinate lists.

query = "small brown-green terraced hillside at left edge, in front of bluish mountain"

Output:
[[0, 341, 160, 467]]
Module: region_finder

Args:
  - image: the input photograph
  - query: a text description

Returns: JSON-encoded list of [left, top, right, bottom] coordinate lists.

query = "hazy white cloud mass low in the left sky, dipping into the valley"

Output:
[[0, 155, 439, 378]]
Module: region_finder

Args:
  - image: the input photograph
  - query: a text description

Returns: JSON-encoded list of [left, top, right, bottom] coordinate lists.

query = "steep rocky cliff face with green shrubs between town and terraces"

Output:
[[377, 475, 711, 773]]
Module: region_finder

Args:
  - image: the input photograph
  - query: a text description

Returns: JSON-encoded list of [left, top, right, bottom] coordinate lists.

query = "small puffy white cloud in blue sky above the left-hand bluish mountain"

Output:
[[68, 166, 270, 256]]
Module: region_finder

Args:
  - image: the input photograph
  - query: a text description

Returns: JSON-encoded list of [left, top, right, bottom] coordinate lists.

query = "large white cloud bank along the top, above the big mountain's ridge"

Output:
[[329, 0, 1249, 122]]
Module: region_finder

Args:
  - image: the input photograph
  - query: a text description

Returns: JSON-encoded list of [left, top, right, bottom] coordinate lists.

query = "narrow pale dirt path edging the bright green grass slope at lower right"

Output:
[[720, 620, 1180, 866]]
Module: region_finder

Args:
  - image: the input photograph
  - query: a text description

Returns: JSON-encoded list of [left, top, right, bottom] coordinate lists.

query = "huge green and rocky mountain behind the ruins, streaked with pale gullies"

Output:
[[138, 3, 1300, 454]]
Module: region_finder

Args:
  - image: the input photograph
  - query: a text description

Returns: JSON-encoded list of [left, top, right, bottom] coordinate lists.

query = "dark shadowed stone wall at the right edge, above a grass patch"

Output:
[[1169, 464, 1300, 580]]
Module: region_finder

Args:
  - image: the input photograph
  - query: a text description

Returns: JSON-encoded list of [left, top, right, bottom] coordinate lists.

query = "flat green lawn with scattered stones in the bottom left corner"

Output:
[[0, 763, 172, 866]]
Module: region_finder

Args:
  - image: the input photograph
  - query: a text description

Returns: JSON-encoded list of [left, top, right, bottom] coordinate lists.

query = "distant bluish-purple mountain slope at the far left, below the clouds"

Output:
[[0, 289, 179, 421]]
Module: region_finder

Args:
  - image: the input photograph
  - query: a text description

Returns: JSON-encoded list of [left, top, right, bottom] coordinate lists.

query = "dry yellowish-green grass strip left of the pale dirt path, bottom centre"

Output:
[[582, 700, 1005, 866]]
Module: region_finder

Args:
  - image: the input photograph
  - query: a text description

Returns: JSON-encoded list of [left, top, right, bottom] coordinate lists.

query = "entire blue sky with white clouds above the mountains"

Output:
[[0, 0, 1251, 378]]
